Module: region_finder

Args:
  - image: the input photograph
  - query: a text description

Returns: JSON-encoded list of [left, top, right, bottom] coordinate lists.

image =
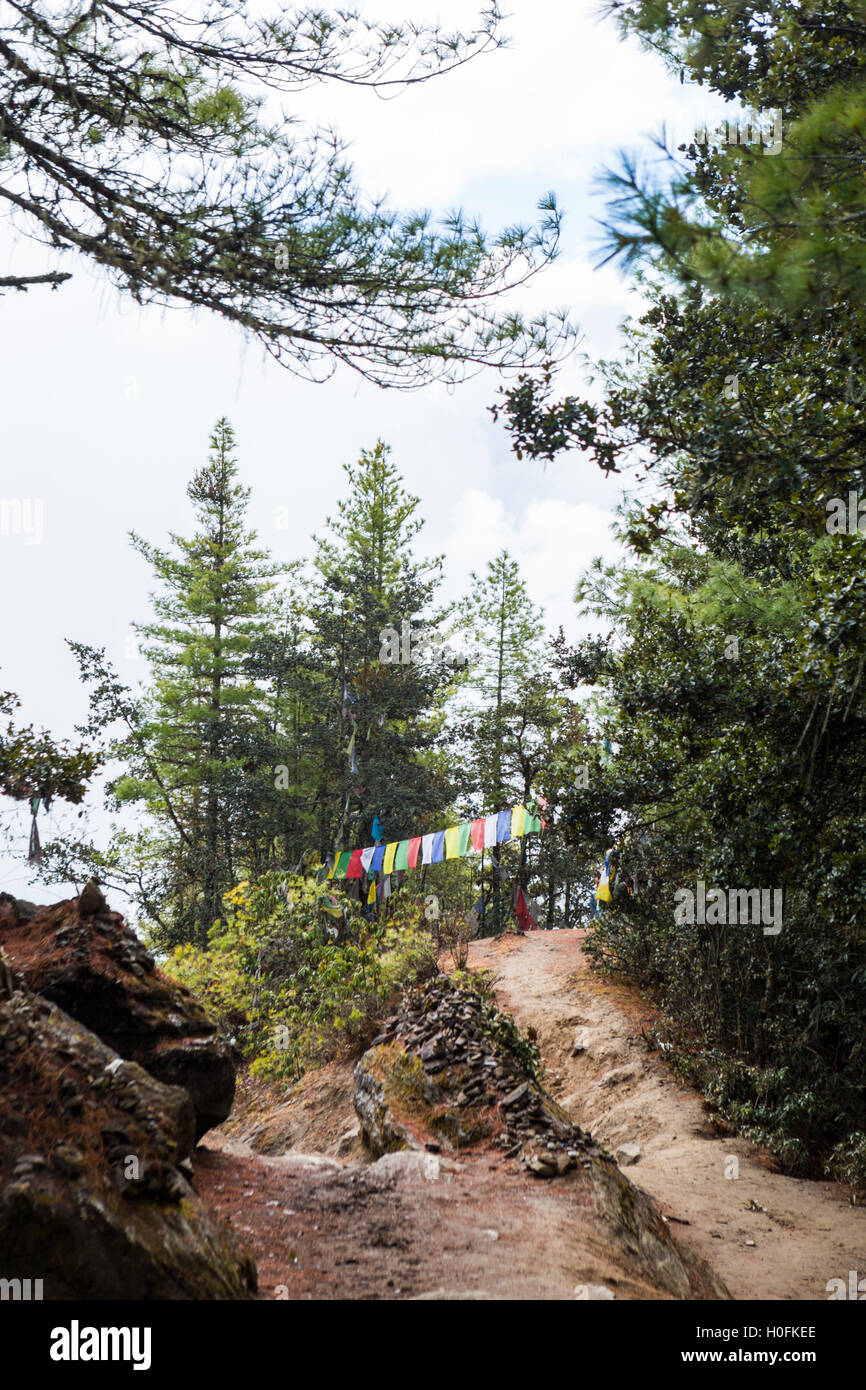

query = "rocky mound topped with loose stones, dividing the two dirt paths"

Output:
[[354, 977, 730, 1300]]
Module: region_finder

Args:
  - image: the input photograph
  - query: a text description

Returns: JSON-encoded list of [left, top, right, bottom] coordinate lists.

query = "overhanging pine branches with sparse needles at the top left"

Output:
[[0, 0, 573, 388]]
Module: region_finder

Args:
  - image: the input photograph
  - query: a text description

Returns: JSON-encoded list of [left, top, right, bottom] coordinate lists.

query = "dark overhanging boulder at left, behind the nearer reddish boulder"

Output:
[[0, 885, 235, 1141]]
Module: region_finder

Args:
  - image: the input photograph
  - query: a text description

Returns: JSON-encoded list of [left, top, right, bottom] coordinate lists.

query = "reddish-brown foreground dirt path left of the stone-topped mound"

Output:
[[195, 1136, 697, 1301]]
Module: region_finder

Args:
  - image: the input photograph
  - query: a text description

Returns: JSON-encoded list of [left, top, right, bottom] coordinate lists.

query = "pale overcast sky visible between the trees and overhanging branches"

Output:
[[0, 0, 719, 901]]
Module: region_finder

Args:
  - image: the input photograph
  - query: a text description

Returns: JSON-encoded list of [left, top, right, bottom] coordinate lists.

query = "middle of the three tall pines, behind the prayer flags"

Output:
[[307, 441, 455, 855]]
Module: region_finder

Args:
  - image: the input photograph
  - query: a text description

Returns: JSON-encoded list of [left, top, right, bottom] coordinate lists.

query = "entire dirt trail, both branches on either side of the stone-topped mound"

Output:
[[195, 931, 866, 1300]]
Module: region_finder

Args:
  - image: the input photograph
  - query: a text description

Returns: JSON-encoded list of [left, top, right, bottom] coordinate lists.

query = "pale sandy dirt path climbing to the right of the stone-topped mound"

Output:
[[470, 931, 866, 1300]]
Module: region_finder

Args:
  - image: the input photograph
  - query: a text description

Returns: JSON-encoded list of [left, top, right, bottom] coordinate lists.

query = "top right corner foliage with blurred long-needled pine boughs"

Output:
[[594, 0, 866, 311]]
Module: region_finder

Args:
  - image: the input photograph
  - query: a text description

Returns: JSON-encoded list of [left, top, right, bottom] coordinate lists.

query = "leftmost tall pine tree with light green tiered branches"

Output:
[[113, 420, 281, 944]]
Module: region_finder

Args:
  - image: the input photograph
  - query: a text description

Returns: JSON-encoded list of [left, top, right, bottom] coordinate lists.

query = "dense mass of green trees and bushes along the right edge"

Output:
[[489, 0, 866, 1186]]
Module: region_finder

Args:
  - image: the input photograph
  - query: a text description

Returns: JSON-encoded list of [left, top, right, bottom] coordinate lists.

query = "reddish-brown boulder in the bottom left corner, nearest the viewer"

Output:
[[0, 954, 256, 1300]]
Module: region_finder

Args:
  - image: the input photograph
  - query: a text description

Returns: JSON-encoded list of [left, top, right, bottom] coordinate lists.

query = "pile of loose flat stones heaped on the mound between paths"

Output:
[[361, 976, 602, 1177]]
